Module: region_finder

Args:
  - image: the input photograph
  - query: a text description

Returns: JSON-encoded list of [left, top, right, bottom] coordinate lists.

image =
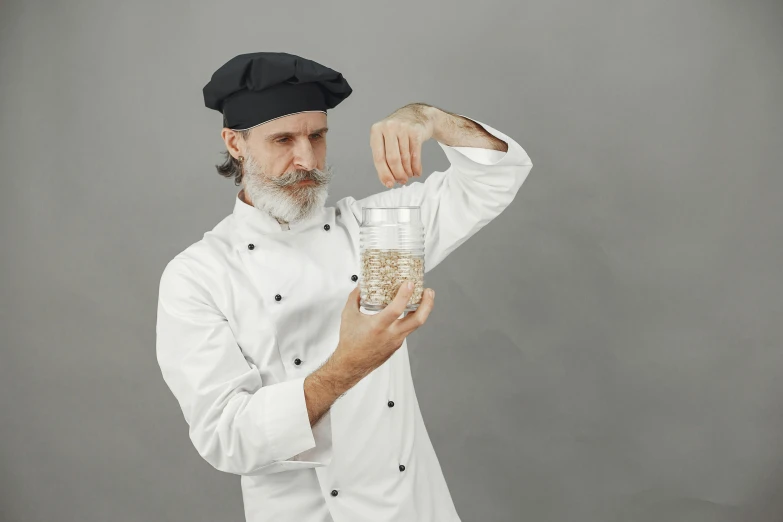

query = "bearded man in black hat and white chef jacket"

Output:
[[157, 53, 532, 522]]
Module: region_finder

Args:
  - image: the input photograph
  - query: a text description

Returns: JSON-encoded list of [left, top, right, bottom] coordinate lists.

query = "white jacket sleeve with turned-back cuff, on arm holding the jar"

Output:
[[156, 258, 332, 475]]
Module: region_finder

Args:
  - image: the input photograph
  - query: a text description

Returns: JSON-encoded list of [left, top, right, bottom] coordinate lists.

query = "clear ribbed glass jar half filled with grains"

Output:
[[359, 207, 424, 312]]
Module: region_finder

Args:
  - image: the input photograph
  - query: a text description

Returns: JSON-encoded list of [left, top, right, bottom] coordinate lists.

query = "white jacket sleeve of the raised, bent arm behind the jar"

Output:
[[349, 118, 533, 272]]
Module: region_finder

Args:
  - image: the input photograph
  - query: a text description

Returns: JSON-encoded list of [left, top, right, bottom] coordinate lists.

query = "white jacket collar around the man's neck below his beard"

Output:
[[233, 190, 335, 248]]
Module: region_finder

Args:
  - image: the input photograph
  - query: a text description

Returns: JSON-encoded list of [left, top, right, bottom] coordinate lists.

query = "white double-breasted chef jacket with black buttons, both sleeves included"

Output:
[[156, 115, 533, 522]]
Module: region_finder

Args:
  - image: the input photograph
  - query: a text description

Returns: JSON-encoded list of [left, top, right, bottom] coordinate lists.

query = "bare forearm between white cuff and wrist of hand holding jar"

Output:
[[304, 354, 364, 426]]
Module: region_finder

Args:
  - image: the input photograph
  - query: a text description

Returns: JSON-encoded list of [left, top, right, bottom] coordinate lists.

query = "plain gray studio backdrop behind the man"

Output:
[[0, 0, 783, 522]]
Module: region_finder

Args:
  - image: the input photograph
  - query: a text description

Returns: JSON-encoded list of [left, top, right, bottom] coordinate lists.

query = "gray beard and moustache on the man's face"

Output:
[[243, 157, 333, 223]]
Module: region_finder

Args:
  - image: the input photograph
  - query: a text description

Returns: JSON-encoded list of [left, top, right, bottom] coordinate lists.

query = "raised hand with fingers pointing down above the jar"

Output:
[[370, 103, 438, 188]]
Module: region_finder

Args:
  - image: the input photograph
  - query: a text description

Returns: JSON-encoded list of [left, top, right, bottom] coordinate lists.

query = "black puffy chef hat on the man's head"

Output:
[[204, 52, 352, 130]]
